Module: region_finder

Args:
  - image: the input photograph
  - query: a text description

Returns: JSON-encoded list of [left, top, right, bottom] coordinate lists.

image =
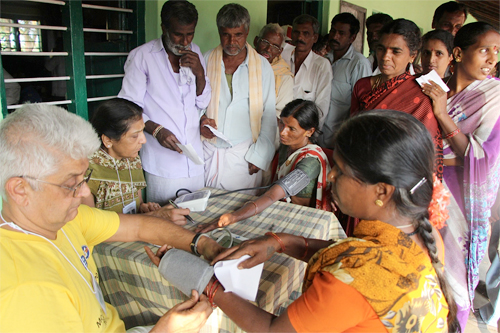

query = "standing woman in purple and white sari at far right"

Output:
[[423, 22, 500, 331]]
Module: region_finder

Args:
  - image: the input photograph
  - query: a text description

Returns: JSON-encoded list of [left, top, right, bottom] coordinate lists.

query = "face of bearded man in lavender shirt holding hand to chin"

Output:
[[161, 18, 196, 56]]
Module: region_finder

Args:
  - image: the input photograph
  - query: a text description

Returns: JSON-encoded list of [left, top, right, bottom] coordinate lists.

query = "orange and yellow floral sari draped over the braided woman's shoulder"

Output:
[[303, 220, 448, 332]]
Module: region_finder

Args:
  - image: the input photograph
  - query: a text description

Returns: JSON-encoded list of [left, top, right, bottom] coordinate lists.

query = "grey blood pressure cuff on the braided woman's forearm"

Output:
[[158, 249, 214, 297]]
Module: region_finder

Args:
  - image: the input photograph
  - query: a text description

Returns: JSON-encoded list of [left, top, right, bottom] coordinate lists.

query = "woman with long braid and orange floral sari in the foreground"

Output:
[[151, 110, 460, 332]]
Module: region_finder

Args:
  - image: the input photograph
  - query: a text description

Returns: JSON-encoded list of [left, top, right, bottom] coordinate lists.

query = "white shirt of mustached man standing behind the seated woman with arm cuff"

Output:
[[281, 48, 333, 129]]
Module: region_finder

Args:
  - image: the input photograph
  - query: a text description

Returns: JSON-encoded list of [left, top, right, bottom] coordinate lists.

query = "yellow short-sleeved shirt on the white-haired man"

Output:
[[0, 205, 125, 332]]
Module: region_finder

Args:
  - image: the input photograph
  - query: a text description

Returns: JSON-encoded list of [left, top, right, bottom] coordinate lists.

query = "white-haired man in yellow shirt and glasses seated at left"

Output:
[[0, 104, 220, 332]]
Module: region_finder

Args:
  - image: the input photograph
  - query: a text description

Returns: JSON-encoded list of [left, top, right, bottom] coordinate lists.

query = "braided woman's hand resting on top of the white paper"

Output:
[[210, 236, 281, 269]]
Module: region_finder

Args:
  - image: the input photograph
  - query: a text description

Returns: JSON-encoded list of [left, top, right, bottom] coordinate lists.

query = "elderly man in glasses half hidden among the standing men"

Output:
[[253, 23, 293, 137]]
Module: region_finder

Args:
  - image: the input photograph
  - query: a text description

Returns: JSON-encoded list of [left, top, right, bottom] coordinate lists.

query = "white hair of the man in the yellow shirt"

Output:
[[0, 104, 101, 200]]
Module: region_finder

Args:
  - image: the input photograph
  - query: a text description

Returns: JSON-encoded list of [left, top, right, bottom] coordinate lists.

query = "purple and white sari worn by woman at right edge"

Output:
[[440, 79, 500, 327]]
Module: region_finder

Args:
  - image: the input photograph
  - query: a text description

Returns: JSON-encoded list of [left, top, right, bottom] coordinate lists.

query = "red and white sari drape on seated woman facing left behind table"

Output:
[[276, 144, 331, 211]]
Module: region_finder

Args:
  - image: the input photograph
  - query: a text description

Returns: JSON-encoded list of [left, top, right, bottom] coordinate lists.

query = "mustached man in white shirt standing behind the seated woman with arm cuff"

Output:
[[282, 14, 332, 129]]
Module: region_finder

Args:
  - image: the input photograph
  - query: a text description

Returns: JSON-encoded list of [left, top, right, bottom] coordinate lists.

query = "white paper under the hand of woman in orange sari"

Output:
[[214, 255, 264, 302]]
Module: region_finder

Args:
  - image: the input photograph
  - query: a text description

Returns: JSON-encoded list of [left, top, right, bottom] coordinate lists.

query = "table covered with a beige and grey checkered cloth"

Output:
[[93, 189, 345, 332]]
